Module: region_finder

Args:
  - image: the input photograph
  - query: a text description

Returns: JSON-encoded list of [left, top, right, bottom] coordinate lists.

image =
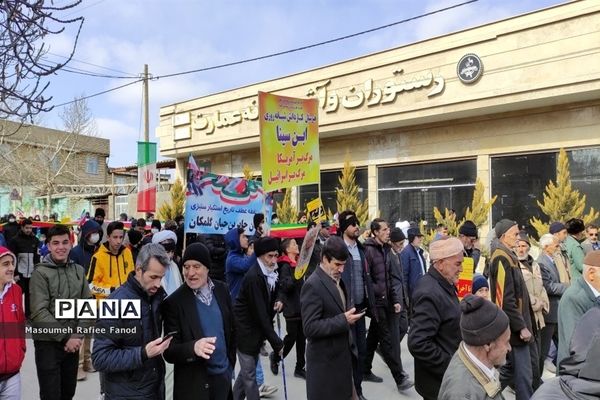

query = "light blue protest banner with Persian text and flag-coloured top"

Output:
[[185, 156, 268, 235]]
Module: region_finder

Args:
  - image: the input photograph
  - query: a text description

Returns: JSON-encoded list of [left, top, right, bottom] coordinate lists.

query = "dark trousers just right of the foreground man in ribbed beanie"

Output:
[[500, 338, 535, 400]]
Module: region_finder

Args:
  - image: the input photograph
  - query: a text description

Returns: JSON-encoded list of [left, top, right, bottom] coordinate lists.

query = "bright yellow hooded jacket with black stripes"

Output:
[[87, 243, 135, 299]]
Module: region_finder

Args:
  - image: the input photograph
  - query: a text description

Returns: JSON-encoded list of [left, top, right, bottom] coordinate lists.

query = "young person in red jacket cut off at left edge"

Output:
[[0, 247, 25, 400]]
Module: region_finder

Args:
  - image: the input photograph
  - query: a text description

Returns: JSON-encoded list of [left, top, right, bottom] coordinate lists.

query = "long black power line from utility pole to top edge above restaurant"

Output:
[[154, 0, 479, 79]]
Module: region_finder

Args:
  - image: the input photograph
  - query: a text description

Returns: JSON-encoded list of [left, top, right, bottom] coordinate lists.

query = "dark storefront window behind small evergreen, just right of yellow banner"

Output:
[[298, 168, 368, 219]]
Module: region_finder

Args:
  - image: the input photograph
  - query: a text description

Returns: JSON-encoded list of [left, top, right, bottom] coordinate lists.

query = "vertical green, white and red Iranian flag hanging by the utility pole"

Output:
[[137, 142, 156, 212]]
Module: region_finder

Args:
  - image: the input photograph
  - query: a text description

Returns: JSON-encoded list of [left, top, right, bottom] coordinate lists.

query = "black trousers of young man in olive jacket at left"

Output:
[[33, 340, 79, 400]]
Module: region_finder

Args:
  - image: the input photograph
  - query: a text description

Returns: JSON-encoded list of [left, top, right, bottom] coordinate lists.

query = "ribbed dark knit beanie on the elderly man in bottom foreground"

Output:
[[460, 295, 508, 346]]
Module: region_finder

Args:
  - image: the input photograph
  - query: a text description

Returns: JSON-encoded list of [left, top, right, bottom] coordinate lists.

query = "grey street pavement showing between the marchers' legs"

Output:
[[21, 318, 552, 400]]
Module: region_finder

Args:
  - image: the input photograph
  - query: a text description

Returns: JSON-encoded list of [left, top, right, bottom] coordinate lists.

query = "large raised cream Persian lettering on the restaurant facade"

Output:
[[172, 69, 446, 140]]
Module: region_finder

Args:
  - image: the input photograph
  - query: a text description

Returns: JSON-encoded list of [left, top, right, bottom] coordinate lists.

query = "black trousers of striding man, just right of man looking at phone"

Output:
[[363, 307, 405, 385]]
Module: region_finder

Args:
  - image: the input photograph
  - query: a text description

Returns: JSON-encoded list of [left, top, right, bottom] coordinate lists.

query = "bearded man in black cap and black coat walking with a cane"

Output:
[[233, 237, 283, 400]]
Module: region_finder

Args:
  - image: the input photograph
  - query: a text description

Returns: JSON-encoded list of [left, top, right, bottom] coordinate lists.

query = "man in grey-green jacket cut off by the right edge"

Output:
[[557, 250, 600, 369]]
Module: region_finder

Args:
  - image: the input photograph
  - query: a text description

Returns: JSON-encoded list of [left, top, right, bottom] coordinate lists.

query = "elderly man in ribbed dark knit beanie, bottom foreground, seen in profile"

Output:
[[438, 295, 511, 400]]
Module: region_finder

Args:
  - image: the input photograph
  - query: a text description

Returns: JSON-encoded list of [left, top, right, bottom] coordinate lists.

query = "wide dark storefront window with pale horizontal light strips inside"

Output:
[[378, 160, 477, 226]]
